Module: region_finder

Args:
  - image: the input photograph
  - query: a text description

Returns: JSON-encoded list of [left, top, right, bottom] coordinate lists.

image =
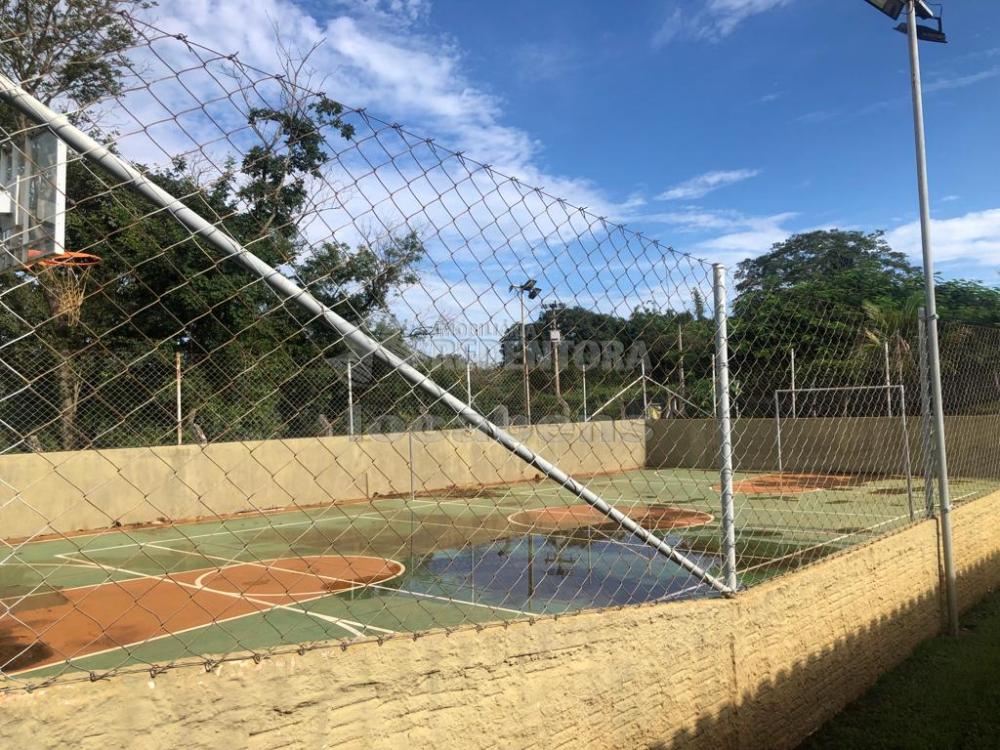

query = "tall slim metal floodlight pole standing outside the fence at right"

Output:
[[906, 0, 958, 635]]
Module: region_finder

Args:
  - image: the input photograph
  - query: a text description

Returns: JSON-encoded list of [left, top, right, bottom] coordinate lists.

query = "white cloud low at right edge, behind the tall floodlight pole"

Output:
[[886, 208, 1000, 266]]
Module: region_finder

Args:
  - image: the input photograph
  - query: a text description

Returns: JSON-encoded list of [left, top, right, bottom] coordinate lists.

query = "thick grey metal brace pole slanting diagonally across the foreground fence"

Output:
[[0, 73, 734, 594]]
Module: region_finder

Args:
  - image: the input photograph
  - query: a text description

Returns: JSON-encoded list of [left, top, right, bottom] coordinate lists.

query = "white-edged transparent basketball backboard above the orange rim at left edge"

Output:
[[0, 131, 67, 271]]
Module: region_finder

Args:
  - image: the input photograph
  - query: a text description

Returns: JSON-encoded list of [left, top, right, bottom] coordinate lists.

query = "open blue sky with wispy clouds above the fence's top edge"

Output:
[[160, 0, 1000, 284]]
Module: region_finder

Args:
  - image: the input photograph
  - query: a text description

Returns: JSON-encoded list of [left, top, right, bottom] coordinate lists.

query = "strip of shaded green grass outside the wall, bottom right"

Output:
[[800, 591, 1000, 750]]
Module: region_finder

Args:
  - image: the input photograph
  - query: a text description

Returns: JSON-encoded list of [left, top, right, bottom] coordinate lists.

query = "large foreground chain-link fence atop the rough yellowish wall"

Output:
[[0, 17, 1000, 689]]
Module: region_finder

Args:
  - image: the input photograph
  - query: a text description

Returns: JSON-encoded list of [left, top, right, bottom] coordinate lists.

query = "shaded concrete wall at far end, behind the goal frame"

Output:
[[647, 415, 1000, 477]]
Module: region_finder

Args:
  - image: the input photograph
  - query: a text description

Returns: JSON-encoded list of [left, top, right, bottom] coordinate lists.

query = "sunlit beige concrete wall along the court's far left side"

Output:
[[0, 420, 646, 539]]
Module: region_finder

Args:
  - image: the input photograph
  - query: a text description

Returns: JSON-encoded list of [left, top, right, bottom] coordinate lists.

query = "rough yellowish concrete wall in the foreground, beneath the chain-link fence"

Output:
[[0, 493, 1000, 750]]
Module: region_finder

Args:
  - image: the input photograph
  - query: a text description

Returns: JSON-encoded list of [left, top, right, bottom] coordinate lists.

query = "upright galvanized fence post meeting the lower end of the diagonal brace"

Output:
[[712, 263, 738, 591]]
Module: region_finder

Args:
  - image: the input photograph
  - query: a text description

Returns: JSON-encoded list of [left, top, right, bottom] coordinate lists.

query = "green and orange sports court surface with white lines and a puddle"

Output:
[[0, 469, 992, 682]]
